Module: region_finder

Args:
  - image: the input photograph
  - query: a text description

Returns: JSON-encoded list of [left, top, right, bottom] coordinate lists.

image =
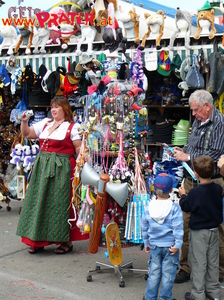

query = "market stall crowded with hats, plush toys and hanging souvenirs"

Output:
[[0, 1, 223, 248]]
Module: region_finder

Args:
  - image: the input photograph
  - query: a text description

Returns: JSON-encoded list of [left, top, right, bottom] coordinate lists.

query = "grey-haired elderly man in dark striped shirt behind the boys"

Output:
[[174, 90, 224, 283]]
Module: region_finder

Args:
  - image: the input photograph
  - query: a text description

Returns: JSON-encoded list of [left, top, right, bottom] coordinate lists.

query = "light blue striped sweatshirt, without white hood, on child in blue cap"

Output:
[[141, 203, 184, 249]]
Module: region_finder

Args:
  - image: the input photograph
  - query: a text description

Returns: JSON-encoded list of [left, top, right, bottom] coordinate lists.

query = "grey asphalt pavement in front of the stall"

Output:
[[0, 201, 224, 300]]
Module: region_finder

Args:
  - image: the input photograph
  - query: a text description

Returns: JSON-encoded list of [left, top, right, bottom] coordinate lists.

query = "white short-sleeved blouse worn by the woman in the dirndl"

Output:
[[33, 118, 81, 141]]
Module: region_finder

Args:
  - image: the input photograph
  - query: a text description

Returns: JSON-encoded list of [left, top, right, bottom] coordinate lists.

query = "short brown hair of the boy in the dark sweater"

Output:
[[193, 155, 215, 179]]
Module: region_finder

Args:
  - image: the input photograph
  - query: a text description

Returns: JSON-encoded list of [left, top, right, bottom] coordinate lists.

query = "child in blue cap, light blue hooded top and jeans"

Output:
[[141, 173, 183, 300]]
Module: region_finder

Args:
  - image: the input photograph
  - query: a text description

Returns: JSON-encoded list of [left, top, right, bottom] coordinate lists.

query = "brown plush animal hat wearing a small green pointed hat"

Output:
[[194, 1, 216, 40]]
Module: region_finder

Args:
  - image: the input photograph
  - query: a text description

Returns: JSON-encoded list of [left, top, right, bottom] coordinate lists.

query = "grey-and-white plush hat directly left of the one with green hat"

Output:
[[168, 7, 192, 51]]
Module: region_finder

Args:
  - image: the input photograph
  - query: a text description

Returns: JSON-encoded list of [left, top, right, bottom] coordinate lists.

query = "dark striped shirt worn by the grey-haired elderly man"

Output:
[[183, 107, 224, 175]]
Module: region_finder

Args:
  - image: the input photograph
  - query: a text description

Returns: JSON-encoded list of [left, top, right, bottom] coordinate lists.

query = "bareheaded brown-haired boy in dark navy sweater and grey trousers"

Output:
[[179, 155, 223, 300]]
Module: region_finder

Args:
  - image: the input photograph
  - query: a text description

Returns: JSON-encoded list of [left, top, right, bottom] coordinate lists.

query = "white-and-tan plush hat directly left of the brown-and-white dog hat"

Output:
[[118, 3, 140, 44]]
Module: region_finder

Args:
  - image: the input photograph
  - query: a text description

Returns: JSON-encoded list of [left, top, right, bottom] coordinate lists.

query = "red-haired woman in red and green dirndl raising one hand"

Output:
[[17, 97, 89, 254]]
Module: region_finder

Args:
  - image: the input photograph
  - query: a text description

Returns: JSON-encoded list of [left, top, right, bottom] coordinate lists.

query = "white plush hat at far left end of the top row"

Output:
[[0, 26, 19, 55]]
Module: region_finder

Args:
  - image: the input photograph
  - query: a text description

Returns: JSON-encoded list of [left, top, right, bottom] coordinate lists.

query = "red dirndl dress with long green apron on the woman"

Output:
[[16, 123, 89, 248]]
